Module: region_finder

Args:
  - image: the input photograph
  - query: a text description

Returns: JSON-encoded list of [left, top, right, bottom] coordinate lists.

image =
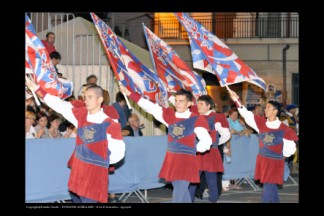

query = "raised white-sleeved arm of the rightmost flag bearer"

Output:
[[228, 89, 259, 133]]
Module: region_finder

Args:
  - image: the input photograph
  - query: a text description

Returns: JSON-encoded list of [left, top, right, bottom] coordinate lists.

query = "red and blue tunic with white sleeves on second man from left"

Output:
[[130, 93, 212, 183]]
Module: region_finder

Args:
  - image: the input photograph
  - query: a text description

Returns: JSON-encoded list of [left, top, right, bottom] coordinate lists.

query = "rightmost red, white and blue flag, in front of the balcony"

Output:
[[175, 13, 266, 90]]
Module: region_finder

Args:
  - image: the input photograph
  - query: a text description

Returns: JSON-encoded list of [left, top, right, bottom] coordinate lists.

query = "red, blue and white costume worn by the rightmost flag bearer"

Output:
[[236, 101, 298, 184]]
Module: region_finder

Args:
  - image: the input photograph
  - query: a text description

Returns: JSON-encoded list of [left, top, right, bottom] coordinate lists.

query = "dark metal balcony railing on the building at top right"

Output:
[[155, 16, 299, 40]]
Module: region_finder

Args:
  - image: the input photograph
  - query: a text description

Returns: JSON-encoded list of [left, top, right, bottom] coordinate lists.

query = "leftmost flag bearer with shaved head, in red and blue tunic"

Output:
[[27, 80, 125, 203]]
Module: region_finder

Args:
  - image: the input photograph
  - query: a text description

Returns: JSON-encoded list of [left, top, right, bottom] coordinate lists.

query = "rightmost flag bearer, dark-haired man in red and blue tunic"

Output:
[[229, 90, 298, 203]]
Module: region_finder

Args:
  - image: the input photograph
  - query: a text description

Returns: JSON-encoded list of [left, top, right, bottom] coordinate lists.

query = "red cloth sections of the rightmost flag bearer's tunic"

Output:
[[254, 116, 298, 184]]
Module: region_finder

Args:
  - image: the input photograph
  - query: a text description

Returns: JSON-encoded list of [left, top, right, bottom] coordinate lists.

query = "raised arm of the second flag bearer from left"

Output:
[[120, 85, 169, 126]]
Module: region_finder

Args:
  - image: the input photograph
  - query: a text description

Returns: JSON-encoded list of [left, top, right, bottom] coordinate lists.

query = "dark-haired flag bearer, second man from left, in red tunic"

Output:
[[120, 85, 212, 203]]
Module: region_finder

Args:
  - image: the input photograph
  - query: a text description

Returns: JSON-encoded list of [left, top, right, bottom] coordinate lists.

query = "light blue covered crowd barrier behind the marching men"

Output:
[[25, 135, 274, 203]]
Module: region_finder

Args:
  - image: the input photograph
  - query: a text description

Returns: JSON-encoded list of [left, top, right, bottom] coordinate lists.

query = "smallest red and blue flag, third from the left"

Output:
[[143, 24, 207, 99]]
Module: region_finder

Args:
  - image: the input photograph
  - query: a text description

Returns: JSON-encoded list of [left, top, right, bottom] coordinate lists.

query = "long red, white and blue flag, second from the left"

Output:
[[91, 13, 169, 107]]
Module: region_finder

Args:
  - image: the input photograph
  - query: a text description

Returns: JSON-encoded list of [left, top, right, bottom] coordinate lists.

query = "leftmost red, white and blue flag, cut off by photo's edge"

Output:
[[25, 14, 73, 99]]
